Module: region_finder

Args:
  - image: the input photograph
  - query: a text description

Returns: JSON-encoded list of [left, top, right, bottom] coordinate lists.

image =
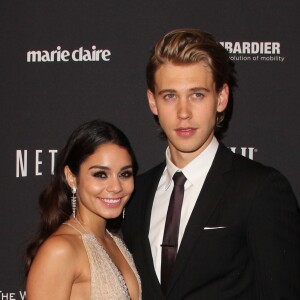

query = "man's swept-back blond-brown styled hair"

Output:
[[146, 28, 236, 136]]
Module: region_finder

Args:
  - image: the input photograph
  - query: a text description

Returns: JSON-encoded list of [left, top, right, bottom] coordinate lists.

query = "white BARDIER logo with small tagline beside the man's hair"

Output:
[[220, 42, 286, 62]]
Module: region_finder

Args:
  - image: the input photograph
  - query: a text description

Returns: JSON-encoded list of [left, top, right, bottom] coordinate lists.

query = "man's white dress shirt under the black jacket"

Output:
[[148, 137, 219, 281]]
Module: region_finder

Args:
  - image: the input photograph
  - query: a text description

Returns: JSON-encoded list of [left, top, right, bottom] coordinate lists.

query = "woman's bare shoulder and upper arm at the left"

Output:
[[26, 229, 80, 299]]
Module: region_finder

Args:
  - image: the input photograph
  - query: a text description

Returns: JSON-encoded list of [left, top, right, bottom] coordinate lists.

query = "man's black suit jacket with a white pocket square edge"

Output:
[[122, 144, 300, 300]]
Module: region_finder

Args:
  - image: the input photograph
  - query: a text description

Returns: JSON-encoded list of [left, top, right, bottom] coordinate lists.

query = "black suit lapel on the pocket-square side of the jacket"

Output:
[[169, 144, 232, 291]]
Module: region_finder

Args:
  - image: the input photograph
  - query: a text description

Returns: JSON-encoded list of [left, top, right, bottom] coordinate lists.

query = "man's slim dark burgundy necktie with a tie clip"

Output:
[[161, 172, 186, 294]]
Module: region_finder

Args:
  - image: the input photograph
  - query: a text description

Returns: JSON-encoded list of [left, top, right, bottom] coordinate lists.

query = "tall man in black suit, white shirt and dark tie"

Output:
[[123, 29, 300, 300]]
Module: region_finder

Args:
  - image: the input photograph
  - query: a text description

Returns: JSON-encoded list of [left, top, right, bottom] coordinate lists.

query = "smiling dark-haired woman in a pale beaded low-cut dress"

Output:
[[26, 120, 141, 300]]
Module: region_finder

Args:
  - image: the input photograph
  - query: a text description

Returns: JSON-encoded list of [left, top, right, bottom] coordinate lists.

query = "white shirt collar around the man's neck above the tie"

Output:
[[165, 137, 219, 190]]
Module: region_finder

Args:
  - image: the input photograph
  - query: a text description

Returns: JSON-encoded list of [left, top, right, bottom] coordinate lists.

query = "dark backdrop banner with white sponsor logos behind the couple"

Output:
[[0, 0, 300, 300]]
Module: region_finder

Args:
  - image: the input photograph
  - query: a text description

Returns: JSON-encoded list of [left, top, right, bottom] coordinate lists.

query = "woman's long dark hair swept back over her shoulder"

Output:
[[25, 120, 138, 275]]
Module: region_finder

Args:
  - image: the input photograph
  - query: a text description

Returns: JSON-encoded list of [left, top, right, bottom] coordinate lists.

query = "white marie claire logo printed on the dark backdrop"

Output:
[[26, 46, 111, 62]]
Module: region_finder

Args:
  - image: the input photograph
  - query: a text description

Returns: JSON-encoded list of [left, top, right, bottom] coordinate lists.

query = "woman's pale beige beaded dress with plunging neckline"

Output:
[[64, 221, 142, 300]]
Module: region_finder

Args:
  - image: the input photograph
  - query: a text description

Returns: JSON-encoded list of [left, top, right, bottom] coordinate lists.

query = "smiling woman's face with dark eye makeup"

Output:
[[69, 143, 134, 219]]
